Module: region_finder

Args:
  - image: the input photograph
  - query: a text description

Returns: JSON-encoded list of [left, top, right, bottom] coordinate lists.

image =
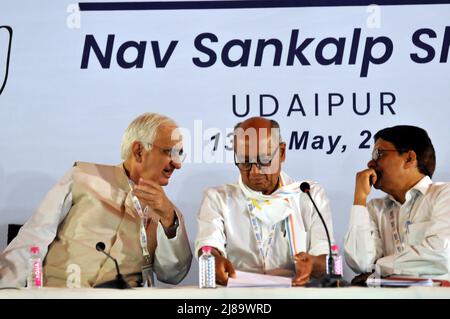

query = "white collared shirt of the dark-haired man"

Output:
[[345, 176, 450, 276]]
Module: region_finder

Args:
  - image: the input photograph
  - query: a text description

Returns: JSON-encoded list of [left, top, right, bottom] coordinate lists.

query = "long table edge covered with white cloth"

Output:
[[0, 286, 450, 299]]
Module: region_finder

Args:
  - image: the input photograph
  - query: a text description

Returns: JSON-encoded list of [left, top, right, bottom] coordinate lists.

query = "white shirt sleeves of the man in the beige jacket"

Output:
[[0, 169, 192, 287]]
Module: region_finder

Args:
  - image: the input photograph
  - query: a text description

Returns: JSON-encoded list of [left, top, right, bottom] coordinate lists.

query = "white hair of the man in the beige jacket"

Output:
[[120, 113, 177, 161]]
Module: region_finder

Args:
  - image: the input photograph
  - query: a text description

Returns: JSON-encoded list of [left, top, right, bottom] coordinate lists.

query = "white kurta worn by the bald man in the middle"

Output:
[[195, 173, 333, 276]]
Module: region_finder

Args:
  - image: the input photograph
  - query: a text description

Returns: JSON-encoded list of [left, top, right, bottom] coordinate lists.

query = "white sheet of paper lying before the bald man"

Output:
[[227, 271, 292, 288]]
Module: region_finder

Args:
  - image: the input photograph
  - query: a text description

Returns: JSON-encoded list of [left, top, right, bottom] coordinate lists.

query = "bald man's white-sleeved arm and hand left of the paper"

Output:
[[195, 188, 236, 285]]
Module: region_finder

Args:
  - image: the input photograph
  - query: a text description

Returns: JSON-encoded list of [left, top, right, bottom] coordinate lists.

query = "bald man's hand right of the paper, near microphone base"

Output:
[[292, 252, 326, 286]]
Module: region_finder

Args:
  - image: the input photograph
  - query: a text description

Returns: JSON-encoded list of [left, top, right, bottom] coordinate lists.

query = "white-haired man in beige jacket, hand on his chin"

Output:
[[0, 113, 192, 287]]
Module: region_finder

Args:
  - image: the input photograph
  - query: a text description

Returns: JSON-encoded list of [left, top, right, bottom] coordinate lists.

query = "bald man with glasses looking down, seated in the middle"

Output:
[[195, 117, 333, 286]]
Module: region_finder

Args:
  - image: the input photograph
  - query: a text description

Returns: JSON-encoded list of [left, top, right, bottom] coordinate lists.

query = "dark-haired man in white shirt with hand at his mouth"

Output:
[[345, 126, 450, 277]]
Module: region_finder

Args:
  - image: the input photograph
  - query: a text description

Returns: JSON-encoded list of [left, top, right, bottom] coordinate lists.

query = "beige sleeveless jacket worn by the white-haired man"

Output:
[[44, 162, 186, 287]]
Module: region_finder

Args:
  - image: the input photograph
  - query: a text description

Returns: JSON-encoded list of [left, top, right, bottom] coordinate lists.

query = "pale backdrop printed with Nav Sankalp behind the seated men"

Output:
[[0, 0, 450, 284]]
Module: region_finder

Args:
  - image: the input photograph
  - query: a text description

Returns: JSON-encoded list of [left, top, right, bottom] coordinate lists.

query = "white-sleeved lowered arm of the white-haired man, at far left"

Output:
[[0, 169, 73, 287]]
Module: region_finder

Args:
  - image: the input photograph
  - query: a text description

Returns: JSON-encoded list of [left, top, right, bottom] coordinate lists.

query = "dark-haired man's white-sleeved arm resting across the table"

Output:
[[377, 184, 450, 276]]
